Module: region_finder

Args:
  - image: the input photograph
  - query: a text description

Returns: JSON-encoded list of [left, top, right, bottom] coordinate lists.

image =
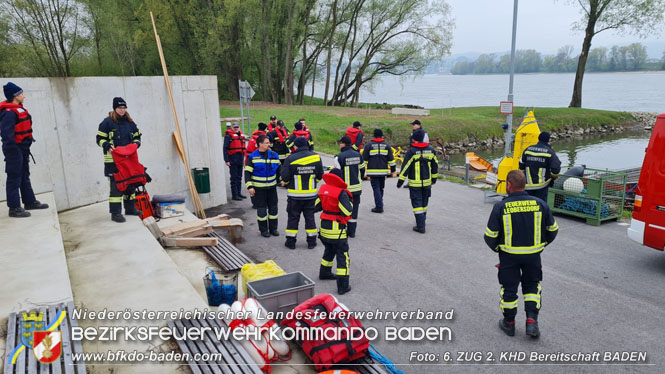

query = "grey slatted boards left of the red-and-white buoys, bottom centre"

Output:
[[168, 319, 263, 374]]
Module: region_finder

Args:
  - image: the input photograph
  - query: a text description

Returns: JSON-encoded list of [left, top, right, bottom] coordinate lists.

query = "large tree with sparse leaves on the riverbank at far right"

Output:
[[569, 0, 665, 108]]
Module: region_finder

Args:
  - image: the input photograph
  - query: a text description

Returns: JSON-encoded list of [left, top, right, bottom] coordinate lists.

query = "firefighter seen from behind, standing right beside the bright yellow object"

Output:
[[520, 132, 561, 203]]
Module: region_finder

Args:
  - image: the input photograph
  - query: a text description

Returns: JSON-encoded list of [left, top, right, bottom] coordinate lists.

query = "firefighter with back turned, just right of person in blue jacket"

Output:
[[281, 138, 323, 249]]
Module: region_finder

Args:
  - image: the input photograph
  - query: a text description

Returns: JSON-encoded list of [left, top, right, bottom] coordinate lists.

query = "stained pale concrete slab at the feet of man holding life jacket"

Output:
[[60, 202, 208, 373]]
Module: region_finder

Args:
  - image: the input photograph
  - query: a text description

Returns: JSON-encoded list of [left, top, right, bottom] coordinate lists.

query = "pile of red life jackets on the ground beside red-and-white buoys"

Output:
[[281, 293, 369, 371]]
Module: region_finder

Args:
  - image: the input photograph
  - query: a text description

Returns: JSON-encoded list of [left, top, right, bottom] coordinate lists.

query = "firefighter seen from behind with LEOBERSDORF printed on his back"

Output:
[[485, 170, 559, 338]]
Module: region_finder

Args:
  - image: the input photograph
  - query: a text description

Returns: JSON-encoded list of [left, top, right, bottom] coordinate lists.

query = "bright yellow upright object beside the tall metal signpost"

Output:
[[496, 110, 540, 193]]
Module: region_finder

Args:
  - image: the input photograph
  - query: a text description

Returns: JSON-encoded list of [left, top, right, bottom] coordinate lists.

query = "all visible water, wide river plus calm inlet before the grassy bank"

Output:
[[315, 71, 665, 169]]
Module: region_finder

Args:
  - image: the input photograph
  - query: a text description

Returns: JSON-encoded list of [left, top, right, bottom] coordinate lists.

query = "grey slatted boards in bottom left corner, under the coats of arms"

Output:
[[4, 301, 86, 374]]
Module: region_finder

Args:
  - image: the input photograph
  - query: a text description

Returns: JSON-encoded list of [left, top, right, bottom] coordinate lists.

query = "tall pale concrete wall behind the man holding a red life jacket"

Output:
[[0, 76, 227, 210]]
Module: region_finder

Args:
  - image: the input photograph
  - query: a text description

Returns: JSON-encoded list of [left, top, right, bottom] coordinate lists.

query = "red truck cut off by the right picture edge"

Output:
[[628, 113, 665, 251]]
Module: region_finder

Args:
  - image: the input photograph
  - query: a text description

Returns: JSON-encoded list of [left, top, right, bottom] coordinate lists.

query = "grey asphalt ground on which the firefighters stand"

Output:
[[209, 154, 665, 373]]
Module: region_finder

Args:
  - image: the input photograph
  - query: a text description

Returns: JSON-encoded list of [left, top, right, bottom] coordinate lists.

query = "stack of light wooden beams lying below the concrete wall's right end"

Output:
[[143, 214, 243, 247]]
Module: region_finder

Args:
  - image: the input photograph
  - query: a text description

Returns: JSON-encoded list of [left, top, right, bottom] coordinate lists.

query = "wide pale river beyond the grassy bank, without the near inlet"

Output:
[[324, 71, 665, 113]]
